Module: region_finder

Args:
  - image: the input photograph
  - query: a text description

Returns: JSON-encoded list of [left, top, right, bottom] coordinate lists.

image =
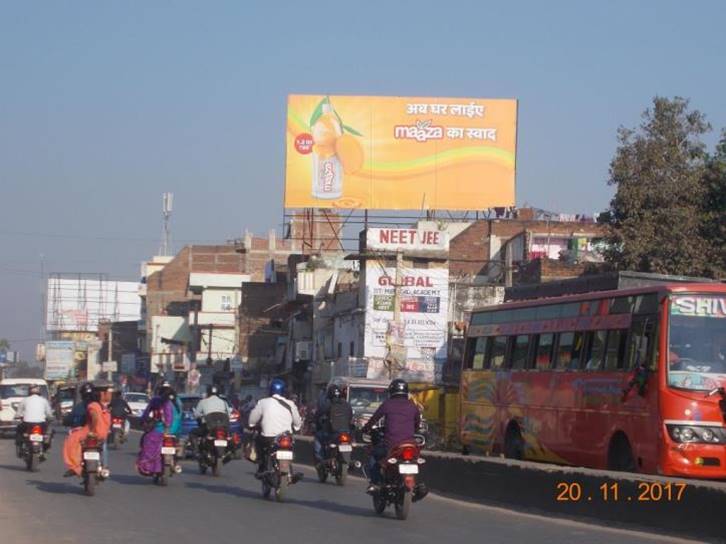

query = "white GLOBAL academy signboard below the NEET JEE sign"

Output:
[[365, 261, 449, 381]]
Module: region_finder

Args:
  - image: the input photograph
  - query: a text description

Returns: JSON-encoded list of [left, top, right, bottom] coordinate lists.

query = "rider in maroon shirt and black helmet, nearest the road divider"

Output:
[[362, 378, 421, 493]]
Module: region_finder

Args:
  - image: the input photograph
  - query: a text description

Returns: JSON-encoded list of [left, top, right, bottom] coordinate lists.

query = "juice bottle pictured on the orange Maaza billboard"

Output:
[[312, 104, 343, 200]]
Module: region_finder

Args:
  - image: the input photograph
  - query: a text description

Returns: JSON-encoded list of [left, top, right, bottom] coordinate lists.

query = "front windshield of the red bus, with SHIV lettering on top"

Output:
[[668, 295, 726, 391]]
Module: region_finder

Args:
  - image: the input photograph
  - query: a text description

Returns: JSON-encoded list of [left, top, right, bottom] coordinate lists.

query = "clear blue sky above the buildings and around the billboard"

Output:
[[0, 0, 726, 362]]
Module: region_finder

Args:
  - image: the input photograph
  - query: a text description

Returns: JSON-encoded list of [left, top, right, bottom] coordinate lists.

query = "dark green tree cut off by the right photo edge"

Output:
[[701, 129, 726, 278]]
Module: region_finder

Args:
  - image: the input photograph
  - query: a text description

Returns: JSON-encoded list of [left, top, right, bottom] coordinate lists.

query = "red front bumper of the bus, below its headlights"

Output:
[[661, 441, 726, 478]]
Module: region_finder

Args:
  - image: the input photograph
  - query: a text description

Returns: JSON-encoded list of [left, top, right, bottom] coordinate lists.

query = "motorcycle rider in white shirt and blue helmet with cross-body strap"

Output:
[[248, 378, 302, 483]]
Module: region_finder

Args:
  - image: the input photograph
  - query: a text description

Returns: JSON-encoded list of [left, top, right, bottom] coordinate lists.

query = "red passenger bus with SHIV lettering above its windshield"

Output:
[[459, 283, 726, 478]]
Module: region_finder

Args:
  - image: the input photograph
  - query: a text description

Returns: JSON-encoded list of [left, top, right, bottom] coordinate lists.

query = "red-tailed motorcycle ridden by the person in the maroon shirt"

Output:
[[364, 428, 428, 520]]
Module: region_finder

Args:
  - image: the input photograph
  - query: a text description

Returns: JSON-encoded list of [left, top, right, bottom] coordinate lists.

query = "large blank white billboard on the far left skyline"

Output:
[[46, 277, 141, 332]]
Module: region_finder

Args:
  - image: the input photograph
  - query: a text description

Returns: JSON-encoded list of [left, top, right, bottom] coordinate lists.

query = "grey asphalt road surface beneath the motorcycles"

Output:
[[0, 431, 704, 544]]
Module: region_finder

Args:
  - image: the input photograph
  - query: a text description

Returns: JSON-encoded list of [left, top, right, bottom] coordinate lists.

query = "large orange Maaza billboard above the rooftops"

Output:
[[285, 95, 517, 210]]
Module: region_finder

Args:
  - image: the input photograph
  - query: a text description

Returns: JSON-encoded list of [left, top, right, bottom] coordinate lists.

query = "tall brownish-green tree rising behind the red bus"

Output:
[[604, 97, 710, 275]]
